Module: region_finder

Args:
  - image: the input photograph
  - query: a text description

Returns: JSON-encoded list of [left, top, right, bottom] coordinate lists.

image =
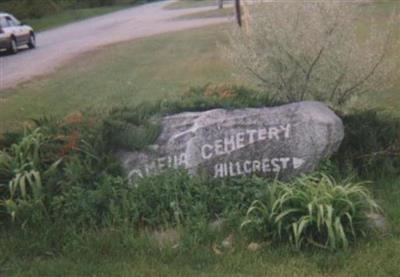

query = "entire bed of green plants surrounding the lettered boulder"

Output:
[[0, 85, 390, 252]]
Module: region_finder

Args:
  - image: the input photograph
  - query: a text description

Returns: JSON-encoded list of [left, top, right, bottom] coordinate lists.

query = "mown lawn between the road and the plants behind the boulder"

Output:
[[0, 26, 233, 132]]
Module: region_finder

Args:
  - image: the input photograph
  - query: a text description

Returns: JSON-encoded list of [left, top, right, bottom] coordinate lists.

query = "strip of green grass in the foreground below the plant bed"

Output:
[[7, 232, 400, 277]]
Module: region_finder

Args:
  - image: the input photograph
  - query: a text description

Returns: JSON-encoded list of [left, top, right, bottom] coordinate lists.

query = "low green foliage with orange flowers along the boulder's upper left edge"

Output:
[[103, 85, 279, 150]]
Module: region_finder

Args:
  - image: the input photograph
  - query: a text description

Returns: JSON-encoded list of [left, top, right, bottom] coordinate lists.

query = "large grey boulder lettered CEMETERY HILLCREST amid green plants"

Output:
[[118, 102, 344, 180]]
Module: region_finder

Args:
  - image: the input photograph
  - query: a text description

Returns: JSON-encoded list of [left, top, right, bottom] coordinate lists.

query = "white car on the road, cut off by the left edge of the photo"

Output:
[[0, 13, 36, 54]]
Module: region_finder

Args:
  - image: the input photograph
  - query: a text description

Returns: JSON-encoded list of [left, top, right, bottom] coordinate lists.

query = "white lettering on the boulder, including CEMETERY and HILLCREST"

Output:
[[128, 124, 305, 179]]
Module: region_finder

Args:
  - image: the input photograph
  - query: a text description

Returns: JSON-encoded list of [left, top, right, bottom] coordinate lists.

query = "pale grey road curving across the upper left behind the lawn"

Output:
[[0, 1, 227, 90]]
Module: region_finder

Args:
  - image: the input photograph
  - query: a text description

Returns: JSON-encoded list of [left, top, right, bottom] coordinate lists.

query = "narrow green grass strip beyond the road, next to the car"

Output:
[[24, 5, 138, 31]]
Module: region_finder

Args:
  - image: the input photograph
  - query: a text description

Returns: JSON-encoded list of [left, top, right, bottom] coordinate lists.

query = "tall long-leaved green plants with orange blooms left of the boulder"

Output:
[[0, 113, 120, 226]]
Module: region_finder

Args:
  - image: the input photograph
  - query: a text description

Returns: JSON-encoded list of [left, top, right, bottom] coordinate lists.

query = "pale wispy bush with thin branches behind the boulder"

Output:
[[226, 1, 399, 107]]
